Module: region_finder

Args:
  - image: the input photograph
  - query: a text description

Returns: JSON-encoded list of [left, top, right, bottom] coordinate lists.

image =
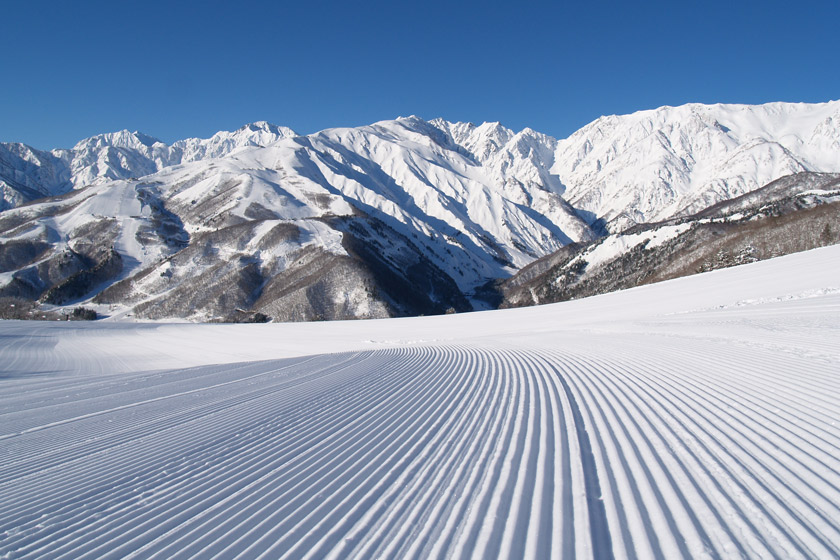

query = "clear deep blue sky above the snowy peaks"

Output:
[[0, 0, 840, 149]]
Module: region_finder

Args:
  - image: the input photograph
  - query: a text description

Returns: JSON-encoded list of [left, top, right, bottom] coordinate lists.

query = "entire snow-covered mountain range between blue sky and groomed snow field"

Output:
[[0, 101, 840, 321]]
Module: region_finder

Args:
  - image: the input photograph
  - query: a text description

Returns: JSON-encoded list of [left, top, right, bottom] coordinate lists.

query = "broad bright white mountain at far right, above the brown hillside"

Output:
[[551, 101, 840, 230]]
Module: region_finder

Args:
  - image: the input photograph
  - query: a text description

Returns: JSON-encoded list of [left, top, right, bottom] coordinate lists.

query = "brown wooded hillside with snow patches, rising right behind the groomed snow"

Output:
[[498, 173, 840, 307]]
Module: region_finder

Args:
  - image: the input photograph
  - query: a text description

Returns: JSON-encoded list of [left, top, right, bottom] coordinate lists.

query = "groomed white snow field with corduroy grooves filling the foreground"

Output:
[[0, 246, 840, 559]]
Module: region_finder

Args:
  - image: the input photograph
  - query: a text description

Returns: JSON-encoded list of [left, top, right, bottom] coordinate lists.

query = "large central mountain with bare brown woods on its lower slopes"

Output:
[[0, 117, 595, 320]]
